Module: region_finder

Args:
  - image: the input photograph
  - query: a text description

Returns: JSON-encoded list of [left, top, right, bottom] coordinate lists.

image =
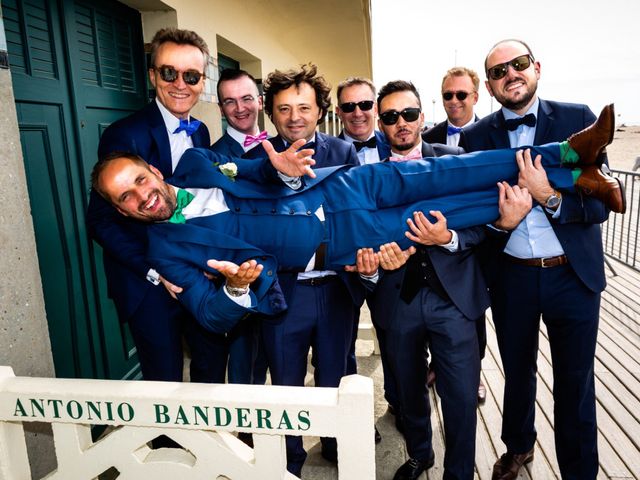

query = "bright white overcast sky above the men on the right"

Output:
[[371, 0, 640, 125]]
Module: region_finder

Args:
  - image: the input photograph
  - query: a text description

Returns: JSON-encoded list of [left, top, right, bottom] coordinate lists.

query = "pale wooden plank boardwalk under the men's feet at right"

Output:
[[303, 253, 640, 480]]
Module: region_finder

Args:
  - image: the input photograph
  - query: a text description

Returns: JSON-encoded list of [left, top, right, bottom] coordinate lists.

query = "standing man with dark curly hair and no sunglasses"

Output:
[[247, 64, 365, 476]]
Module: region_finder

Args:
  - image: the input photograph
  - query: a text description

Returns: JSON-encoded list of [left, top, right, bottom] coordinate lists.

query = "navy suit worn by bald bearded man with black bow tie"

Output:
[[460, 100, 609, 479]]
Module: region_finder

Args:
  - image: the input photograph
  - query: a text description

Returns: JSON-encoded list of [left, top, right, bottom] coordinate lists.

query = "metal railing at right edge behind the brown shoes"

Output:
[[602, 170, 640, 271]]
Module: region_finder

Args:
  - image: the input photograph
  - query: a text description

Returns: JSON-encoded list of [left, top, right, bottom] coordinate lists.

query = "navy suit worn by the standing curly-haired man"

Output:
[[246, 132, 365, 474]]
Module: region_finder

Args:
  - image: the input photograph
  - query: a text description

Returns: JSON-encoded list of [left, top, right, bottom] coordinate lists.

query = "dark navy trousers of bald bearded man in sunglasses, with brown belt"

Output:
[[491, 258, 600, 480]]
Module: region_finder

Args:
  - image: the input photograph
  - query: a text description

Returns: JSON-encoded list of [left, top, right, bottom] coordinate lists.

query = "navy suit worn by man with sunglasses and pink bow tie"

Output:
[[372, 142, 482, 479]]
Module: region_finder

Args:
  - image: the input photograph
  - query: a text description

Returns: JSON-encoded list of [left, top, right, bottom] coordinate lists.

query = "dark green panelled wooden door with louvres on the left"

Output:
[[1, 0, 146, 378]]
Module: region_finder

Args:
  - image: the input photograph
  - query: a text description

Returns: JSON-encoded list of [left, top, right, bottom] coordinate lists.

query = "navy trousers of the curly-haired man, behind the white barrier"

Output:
[[262, 276, 358, 476]]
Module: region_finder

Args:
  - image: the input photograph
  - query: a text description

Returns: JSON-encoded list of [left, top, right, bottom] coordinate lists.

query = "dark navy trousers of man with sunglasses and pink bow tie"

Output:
[[387, 287, 480, 479]]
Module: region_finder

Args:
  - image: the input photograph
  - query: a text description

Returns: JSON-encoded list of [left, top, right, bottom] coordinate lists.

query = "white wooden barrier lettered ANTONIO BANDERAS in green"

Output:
[[0, 367, 375, 480]]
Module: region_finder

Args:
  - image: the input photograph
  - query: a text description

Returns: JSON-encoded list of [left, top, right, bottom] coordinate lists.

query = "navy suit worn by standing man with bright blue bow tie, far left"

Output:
[[87, 101, 232, 381]]
